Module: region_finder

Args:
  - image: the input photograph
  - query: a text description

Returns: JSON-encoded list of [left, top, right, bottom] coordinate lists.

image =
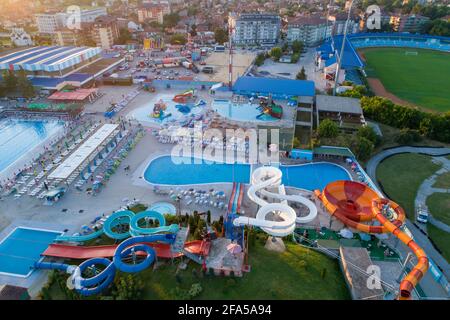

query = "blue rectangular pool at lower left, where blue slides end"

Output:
[[0, 228, 61, 276]]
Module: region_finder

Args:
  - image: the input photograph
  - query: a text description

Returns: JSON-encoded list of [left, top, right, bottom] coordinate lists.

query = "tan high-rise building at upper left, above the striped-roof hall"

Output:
[[92, 16, 119, 49]]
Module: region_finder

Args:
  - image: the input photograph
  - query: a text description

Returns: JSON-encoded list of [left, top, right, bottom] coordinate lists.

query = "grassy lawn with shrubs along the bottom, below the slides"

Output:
[[44, 241, 350, 300]]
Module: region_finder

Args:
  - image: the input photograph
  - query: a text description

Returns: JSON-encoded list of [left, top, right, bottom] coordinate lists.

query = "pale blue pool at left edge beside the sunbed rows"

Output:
[[0, 119, 64, 172]]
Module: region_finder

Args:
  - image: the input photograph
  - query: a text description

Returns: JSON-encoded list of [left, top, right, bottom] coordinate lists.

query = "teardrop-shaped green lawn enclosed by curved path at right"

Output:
[[377, 153, 439, 219]]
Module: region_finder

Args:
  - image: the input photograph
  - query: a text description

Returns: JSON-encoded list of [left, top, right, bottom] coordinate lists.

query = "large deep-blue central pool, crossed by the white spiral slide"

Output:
[[144, 156, 351, 191]]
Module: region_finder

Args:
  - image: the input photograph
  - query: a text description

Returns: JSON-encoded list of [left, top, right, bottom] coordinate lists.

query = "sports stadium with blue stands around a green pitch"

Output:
[[317, 33, 450, 112]]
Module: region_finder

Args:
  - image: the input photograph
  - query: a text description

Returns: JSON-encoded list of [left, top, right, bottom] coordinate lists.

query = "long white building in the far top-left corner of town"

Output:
[[34, 7, 108, 34]]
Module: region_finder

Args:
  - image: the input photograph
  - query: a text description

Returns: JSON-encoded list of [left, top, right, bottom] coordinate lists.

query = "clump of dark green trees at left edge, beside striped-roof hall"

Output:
[[0, 69, 36, 98]]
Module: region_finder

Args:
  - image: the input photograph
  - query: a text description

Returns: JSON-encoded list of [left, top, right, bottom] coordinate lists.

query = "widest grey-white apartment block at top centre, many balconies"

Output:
[[228, 13, 281, 45]]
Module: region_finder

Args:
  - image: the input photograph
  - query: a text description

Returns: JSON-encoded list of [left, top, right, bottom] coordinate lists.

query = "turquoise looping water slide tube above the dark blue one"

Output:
[[55, 210, 178, 242]]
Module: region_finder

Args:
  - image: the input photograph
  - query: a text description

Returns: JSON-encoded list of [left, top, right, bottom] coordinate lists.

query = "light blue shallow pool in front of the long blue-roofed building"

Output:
[[211, 99, 278, 121]]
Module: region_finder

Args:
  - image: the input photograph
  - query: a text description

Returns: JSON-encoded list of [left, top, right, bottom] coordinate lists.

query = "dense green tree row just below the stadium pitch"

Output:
[[361, 97, 450, 143]]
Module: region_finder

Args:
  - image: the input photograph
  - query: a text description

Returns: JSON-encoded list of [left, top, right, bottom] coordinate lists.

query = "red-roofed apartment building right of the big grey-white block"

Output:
[[286, 16, 332, 46]]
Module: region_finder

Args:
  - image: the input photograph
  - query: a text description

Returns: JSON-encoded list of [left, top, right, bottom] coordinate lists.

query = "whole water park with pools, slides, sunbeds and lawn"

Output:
[[0, 73, 442, 300]]
